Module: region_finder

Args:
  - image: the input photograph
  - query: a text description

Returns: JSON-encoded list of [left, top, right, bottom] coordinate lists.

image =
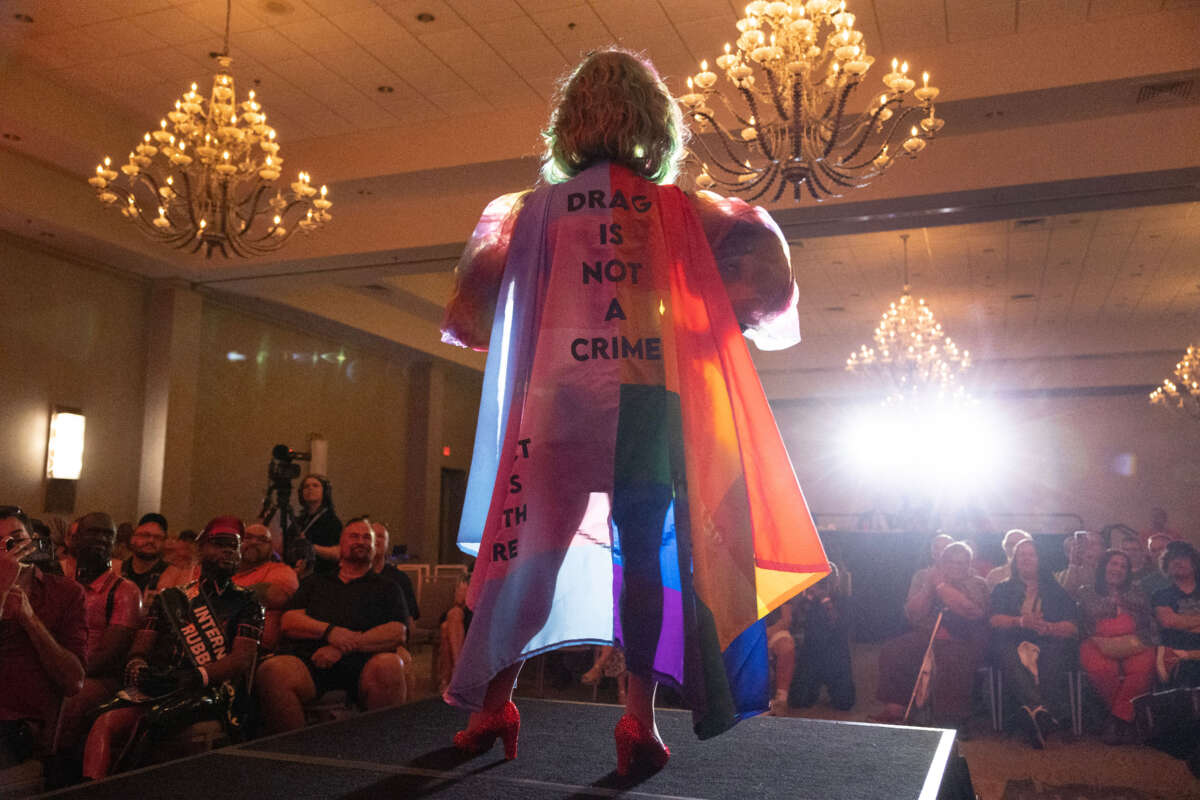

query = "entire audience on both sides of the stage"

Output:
[[0, 494, 1200, 787]]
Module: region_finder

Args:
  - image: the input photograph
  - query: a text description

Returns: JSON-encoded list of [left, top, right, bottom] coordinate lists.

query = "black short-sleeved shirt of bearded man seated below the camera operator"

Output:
[[281, 571, 408, 658]]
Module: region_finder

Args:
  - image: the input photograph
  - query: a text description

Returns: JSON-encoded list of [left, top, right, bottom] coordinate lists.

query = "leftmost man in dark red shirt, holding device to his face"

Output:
[[0, 506, 88, 764]]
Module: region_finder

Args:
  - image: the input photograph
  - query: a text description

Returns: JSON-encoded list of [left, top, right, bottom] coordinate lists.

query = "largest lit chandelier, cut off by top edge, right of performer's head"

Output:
[[679, 0, 943, 201]]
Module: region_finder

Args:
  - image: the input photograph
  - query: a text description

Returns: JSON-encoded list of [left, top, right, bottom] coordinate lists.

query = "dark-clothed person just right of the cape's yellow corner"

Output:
[[788, 563, 854, 711]]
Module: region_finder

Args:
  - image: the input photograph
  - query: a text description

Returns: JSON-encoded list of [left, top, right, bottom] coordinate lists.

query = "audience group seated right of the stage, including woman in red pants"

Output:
[[872, 527, 1200, 748]]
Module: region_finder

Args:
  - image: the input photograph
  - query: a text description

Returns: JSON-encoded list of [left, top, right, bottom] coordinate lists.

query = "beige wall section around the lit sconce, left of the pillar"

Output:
[[0, 236, 149, 519]]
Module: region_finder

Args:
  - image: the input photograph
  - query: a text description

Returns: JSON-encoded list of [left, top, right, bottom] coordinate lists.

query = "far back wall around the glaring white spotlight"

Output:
[[776, 392, 1200, 543]]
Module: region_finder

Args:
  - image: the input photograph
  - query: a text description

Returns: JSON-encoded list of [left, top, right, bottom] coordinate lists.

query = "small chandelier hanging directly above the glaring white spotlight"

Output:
[[846, 234, 971, 404]]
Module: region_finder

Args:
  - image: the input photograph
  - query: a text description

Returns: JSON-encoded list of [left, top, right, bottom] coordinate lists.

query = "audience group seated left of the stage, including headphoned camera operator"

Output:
[[0, 479, 441, 788]]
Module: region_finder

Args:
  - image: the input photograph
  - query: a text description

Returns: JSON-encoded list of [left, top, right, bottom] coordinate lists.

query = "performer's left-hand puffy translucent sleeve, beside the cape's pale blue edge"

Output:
[[442, 192, 528, 350]]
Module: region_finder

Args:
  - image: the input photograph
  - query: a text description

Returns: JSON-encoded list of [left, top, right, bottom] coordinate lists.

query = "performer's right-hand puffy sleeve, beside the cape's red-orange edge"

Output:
[[689, 191, 800, 350]]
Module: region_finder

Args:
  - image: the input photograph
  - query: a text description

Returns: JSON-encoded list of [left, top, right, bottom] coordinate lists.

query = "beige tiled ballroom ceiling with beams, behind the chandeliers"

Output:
[[0, 0, 1200, 395]]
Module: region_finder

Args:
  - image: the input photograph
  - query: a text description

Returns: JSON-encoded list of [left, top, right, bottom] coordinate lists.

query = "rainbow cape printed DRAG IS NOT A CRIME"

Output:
[[445, 163, 829, 738]]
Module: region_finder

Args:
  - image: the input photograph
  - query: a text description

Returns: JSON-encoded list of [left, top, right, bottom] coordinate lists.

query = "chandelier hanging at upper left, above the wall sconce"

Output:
[[88, 0, 332, 258]]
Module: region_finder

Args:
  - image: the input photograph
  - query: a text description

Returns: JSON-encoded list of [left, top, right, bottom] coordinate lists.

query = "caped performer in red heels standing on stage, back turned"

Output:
[[443, 49, 829, 775]]
